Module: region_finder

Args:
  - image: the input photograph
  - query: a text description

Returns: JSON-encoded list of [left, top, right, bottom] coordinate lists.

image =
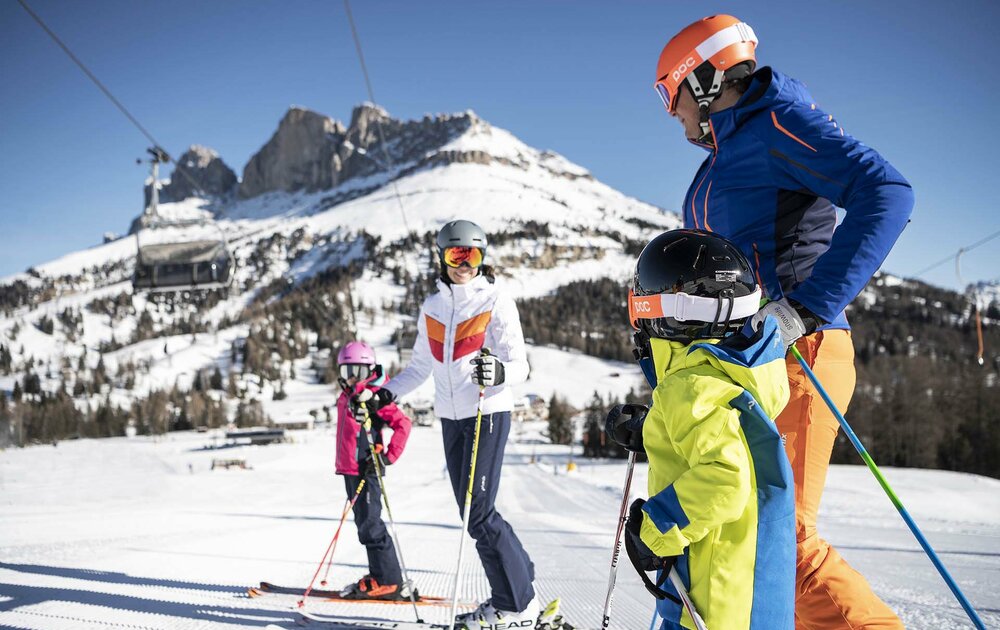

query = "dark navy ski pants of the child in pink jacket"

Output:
[[344, 474, 403, 584]]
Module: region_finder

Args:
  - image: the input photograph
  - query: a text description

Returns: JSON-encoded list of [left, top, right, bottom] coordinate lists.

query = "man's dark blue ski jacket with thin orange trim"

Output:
[[683, 67, 913, 328]]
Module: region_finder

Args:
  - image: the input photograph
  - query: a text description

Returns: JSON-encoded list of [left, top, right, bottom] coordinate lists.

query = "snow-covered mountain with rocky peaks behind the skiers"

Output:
[[0, 105, 679, 444]]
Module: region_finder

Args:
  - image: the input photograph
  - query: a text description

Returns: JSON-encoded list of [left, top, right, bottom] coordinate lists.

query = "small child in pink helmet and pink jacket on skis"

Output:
[[337, 341, 410, 600]]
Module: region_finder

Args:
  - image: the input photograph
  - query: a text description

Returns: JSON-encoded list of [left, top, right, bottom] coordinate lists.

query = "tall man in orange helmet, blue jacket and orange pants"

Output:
[[654, 15, 913, 630]]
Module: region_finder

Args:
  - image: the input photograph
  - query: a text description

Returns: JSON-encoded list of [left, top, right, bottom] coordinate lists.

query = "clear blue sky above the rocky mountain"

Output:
[[0, 0, 1000, 286]]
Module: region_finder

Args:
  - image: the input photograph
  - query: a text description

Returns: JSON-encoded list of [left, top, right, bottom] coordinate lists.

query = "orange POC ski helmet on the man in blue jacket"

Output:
[[653, 15, 757, 118]]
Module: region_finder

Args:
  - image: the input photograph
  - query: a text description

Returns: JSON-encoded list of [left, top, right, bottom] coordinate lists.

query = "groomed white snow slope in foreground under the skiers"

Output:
[[0, 425, 1000, 630]]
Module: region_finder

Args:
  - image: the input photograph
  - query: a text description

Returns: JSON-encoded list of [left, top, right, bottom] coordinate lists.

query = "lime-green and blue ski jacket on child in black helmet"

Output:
[[641, 317, 795, 630]]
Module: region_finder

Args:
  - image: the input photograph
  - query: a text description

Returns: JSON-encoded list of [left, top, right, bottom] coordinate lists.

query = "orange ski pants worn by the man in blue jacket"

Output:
[[776, 330, 903, 630]]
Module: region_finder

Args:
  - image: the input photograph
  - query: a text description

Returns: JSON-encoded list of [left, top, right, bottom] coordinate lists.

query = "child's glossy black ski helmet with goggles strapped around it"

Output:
[[629, 230, 761, 342]]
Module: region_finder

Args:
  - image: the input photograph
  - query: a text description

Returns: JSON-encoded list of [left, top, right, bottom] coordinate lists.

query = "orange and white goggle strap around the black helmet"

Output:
[[628, 287, 761, 330]]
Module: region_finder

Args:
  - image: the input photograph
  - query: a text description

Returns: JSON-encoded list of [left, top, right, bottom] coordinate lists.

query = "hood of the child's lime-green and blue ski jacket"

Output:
[[650, 317, 788, 418]]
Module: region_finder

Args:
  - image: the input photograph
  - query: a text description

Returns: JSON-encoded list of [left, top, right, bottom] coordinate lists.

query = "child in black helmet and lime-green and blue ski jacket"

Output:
[[608, 230, 795, 630]]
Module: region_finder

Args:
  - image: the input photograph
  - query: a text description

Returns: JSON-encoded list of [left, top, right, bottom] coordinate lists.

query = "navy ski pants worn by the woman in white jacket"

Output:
[[441, 411, 535, 612]]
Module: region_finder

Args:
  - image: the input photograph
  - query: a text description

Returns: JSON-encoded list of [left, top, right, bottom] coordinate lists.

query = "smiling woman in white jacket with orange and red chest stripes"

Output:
[[352, 221, 539, 630]]
